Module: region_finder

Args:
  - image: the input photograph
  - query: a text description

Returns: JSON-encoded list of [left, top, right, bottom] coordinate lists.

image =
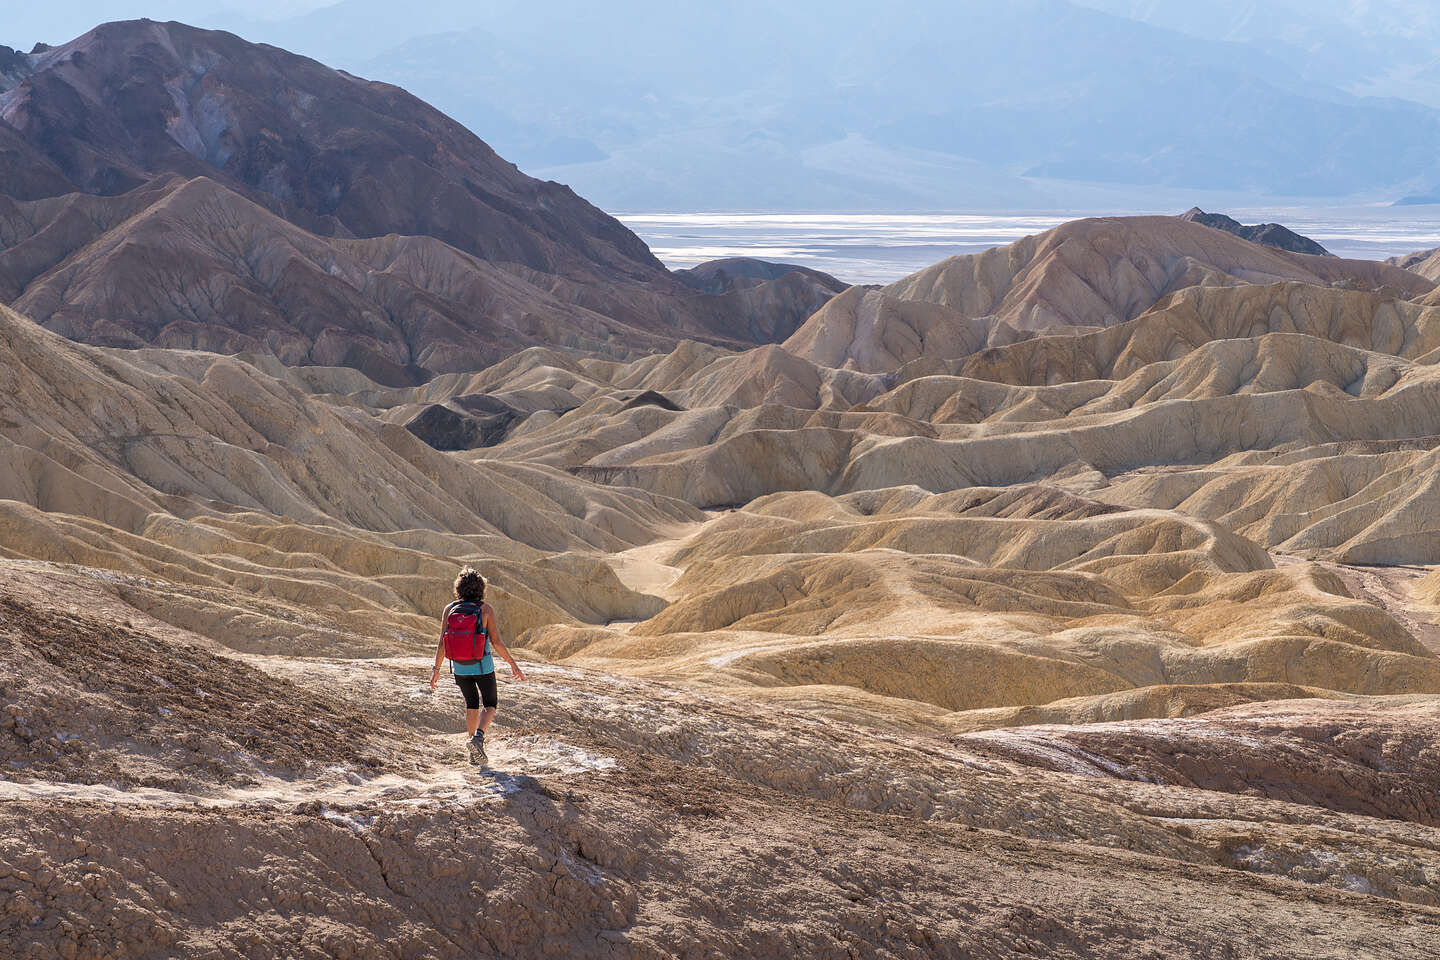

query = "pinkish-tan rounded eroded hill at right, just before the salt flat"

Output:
[[785, 217, 1434, 373]]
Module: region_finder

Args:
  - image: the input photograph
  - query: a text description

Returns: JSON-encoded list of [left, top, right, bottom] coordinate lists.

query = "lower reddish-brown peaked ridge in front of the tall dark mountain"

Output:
[[0, 177, 766, 386]]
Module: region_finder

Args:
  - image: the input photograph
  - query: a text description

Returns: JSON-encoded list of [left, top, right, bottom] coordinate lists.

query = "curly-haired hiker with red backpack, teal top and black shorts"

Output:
[[431, 567, 526, 764]]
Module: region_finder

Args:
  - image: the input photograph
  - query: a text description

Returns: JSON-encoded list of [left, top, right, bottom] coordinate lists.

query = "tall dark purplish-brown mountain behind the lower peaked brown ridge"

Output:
[[0, 20, 665, 279]]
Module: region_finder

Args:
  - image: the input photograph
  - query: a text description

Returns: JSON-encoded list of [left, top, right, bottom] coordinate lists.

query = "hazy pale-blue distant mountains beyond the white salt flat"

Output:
[[140, 0, 1440, 210]]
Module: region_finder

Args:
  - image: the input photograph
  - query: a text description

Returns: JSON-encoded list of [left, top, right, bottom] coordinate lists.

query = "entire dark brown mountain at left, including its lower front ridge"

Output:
[[0, 20, 838, 384]]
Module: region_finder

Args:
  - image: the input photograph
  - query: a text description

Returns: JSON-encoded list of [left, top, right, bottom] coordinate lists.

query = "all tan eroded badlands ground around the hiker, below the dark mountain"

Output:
[[0, 217, 1440, 959]]
